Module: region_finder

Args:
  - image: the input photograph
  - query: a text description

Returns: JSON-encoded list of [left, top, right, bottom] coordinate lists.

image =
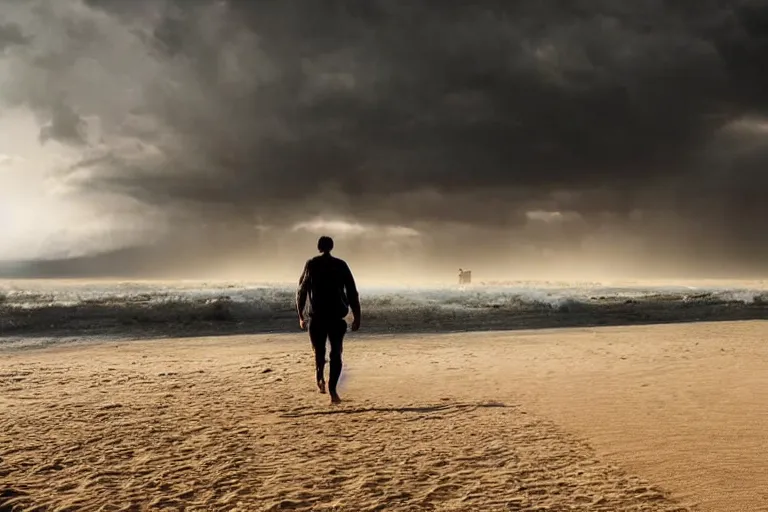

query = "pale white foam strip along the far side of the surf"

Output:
[[0, 281, 768, 311]]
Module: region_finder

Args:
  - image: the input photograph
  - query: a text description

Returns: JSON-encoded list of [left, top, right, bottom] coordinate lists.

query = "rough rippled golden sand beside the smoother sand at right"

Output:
[[0, 337, 686, 511]]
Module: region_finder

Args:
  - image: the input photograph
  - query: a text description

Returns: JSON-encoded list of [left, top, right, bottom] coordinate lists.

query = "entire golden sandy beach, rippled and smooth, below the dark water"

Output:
[[0, 321, 768, 512]]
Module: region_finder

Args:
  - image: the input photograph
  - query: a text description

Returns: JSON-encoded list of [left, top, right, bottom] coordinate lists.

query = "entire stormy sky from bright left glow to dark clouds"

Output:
[[0, 0, 768, 279]]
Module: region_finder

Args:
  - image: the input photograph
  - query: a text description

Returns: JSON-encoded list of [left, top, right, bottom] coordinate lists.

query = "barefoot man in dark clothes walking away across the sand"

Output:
[[296, 236, 360, 404]]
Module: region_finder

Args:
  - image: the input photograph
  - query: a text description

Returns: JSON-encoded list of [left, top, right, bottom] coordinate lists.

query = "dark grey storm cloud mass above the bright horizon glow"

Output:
[[0, 0, 768, 272]]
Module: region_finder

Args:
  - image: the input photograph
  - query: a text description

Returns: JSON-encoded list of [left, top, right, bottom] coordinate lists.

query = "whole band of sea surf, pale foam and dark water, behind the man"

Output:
[[0, 281, 768, 341]]
